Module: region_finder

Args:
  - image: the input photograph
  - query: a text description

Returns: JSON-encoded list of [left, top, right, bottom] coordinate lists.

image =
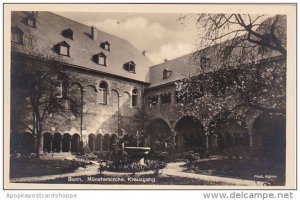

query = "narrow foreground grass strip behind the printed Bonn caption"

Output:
[[36, 174, 225, 185]]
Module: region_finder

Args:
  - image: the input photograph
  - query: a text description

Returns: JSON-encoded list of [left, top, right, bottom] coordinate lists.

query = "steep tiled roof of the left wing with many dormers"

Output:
[[12, 12, 152, 82]]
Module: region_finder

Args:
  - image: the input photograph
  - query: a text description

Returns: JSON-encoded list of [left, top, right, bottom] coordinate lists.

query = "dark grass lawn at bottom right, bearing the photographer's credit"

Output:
[[186, 159, 285, 185]]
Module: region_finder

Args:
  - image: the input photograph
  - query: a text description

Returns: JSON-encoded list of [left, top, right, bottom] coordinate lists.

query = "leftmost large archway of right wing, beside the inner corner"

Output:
[[145, 119, 173, 151]]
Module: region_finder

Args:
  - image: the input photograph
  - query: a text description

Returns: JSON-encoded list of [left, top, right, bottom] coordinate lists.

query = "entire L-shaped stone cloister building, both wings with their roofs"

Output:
[[11, 12, 285, 159]]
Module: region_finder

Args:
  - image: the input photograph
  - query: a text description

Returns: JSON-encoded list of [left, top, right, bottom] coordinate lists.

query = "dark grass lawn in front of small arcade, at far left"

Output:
[[10, 157, 84, 178]]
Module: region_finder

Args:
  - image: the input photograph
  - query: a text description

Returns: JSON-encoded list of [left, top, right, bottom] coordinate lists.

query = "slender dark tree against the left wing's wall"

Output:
[[11, 31, 70, 157]]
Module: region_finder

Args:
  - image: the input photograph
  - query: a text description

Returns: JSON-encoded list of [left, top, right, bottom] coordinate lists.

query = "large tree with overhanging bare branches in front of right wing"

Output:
[[177, 14, 286, 126]]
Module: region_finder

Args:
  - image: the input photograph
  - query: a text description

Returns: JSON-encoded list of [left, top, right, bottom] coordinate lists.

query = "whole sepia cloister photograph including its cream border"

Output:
[[4, 4, 296, 189]]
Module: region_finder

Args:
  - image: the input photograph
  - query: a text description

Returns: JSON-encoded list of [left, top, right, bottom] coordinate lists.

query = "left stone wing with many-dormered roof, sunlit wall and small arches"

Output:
[[11, 12, 151, 155]]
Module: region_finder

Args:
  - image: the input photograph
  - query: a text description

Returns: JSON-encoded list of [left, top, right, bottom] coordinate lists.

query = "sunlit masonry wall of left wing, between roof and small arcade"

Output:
[[11, 54, 145, 148]]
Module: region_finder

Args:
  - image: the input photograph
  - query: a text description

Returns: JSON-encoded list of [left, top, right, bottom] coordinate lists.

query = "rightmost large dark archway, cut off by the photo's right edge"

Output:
[[252, 113, 286, 160]]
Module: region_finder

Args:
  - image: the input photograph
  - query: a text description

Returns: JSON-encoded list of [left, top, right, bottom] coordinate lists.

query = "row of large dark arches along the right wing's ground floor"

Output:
[[145, 112, 286, 158]]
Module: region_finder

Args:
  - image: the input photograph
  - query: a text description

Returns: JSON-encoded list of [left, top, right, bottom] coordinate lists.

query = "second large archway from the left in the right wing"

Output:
[[174, 116, 205, 153]]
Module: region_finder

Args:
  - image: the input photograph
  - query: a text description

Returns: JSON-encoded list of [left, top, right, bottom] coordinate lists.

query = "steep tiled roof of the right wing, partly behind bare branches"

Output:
[[149, 15, 286, 88]]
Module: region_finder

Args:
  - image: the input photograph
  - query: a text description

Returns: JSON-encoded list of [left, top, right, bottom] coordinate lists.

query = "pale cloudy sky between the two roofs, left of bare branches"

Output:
[[56, 12, 199, 64]]
